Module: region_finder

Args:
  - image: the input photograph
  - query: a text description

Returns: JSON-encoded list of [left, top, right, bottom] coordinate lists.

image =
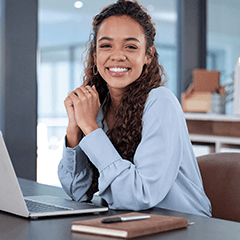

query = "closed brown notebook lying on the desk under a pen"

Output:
[[71, 212, 188, 238]]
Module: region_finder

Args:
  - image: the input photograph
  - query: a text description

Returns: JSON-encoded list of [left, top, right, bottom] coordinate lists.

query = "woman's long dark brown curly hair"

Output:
[[84, 0, 165, 163]]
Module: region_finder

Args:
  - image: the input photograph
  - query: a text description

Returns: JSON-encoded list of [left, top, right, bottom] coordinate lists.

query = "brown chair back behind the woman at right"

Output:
[[197, 152, 240, 222]]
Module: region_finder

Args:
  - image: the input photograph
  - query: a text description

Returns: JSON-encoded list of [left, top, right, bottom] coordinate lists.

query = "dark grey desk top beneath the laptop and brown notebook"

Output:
[[0, 179, 240, 240]]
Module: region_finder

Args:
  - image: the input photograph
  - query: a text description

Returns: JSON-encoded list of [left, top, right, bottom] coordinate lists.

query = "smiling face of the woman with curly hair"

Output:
[[95, 16, 149, 92]]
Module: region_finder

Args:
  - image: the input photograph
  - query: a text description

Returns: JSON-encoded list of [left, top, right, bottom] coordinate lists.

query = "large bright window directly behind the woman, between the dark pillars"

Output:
[[37, 0, 177, 186]]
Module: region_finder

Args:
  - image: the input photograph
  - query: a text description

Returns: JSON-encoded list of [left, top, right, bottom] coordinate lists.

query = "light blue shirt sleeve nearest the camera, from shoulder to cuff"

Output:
[[80, 88, 185, 210]]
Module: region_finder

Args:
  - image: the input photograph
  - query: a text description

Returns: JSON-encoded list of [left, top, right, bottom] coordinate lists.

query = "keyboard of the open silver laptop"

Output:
[[25, 199, 72, 213]]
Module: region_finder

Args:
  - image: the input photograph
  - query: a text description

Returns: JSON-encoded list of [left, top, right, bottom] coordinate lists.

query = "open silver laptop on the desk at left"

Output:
[[0, 131, 108, 219]]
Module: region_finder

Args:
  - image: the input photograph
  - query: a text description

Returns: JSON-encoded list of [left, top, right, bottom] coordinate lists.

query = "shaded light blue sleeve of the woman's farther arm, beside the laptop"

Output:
[[58, 138, 93, 201]]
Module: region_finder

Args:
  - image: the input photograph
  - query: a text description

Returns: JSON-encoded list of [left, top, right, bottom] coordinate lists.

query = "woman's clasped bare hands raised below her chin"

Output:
[[64, 85, 101, 147]]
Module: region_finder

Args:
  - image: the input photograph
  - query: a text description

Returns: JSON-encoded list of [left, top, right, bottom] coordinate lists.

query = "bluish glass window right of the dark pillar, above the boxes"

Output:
[[207, 0, 240, 114]]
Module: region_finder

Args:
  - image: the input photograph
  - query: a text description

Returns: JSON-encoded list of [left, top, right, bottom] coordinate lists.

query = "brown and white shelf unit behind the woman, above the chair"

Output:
[[184, 113, 240, 152]]
